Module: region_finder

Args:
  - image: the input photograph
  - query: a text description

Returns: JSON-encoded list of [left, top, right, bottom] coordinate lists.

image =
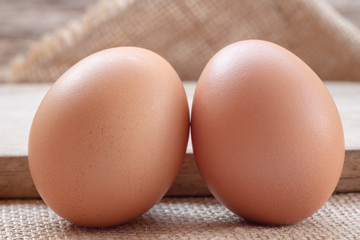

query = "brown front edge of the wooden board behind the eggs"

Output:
[[0, 150, 360, 199]]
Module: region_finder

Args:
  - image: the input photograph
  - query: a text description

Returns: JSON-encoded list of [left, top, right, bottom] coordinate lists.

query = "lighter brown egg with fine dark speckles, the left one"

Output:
[[29, 47, 189, 227]]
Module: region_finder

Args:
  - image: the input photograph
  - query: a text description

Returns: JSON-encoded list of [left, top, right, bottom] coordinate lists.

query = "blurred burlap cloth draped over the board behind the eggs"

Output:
[[7, 0, 360, 82]]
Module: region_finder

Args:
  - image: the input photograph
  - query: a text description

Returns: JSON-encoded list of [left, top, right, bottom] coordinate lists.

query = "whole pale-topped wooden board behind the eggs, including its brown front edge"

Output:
[[0, 81, 360, 198]]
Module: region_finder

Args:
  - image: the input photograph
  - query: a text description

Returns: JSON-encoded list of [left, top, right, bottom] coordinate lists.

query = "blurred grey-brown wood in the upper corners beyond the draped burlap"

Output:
[[0, 0, 360, 82]]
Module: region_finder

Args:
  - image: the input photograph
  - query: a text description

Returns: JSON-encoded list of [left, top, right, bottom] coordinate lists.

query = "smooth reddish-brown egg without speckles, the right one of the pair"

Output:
[[191, 40, 344, 224]]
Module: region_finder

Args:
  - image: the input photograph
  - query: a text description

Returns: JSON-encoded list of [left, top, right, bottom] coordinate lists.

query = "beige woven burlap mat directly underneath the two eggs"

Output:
[[0, 193, 360, 239]]
